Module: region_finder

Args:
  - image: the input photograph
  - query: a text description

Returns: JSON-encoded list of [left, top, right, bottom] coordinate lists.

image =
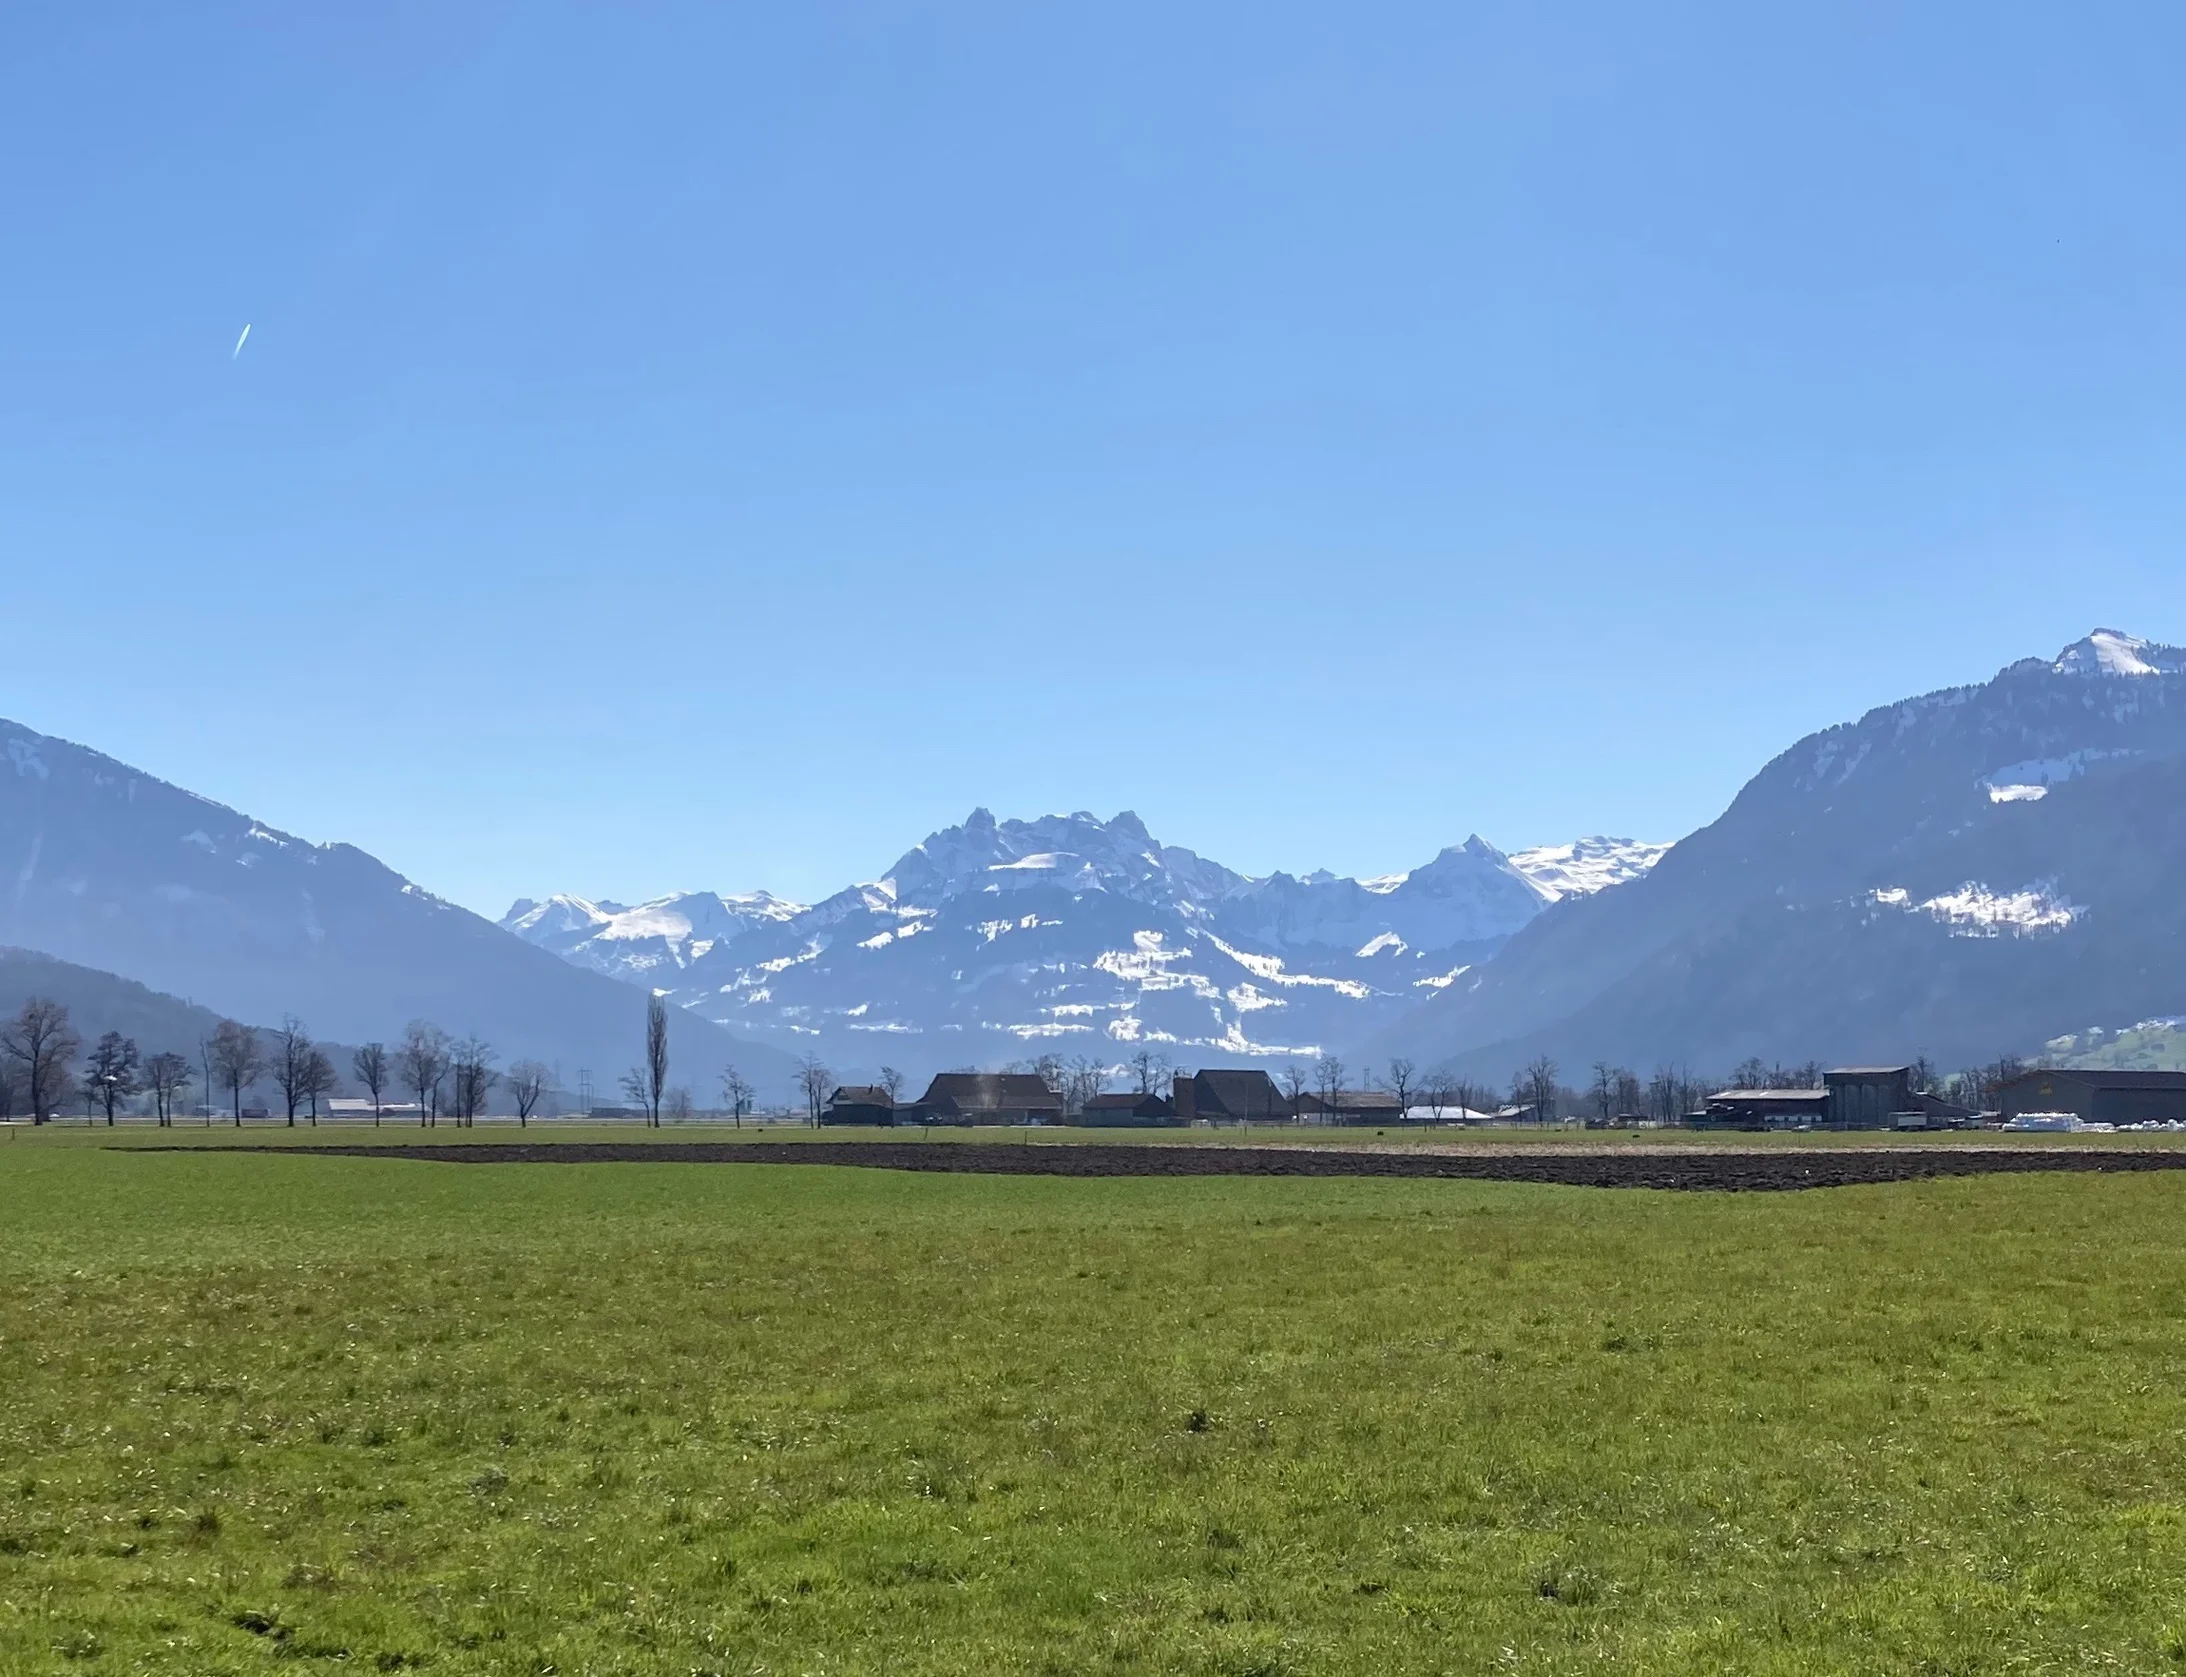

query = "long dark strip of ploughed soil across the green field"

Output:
[[166, 1141, 2186, 1192]]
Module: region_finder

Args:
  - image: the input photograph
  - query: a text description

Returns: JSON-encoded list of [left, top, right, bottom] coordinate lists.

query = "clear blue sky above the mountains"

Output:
[[0, 0, 2186, 914]]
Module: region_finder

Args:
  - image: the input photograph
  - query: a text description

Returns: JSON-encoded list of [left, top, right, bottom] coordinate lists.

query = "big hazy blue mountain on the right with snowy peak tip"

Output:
[[1373, 630, 2186, 1076]]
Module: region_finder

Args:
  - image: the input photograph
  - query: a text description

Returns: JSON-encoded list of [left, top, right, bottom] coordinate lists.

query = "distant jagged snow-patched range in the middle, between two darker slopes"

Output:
[[501, 809, 1666, 1076]]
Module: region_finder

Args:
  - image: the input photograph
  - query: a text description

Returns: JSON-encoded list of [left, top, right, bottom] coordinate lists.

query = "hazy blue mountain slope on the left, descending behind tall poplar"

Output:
[[0, 722, 787, 1087]]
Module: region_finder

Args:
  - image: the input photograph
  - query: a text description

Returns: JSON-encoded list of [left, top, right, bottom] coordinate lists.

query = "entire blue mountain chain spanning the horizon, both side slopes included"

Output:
[[0, 630, 2186, 1100]]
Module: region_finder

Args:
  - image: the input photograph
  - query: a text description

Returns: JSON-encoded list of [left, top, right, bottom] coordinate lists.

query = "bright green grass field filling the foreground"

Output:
[[0, 1130, 2186, 1677]]
